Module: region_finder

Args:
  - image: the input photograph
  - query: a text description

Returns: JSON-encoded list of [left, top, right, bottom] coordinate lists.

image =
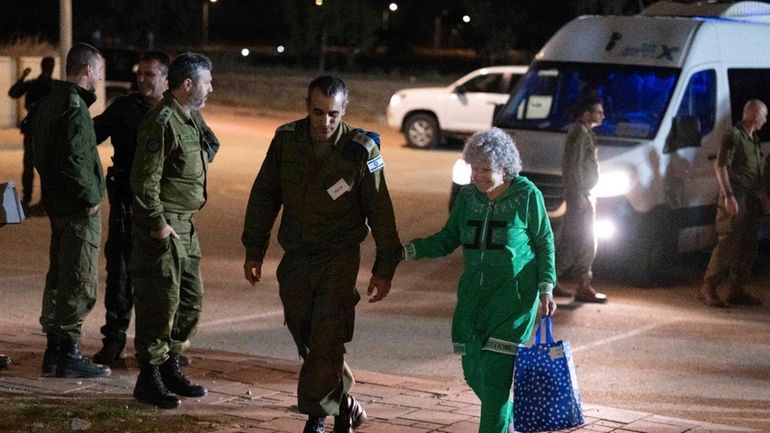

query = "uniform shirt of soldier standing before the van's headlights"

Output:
[[562, 122, 599, 198]]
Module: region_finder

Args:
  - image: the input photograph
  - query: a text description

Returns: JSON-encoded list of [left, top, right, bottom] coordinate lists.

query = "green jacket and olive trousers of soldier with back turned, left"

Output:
[[31, 82, 105, 343]]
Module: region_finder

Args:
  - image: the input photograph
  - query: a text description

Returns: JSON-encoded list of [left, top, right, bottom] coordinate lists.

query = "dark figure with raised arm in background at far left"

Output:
[[8, 57, 58, 213]]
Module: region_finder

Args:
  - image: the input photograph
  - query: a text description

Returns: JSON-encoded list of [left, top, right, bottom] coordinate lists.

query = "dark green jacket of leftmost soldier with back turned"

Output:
[[30, 81, 105, 217]]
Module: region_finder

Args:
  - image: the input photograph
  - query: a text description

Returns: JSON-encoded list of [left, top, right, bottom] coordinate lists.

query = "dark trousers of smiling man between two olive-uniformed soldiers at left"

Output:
[[101, 186, 134, 348]]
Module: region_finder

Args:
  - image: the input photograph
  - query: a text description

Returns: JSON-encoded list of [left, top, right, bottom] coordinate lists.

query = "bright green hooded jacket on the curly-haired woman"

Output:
[[406, 176, 556, 353]]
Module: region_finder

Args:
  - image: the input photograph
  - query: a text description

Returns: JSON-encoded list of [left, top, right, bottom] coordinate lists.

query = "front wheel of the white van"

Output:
[[626, 207, 679, 287]]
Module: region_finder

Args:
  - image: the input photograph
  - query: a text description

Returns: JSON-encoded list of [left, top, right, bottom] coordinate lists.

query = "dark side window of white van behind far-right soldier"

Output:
[[727, 68, 770, 141]]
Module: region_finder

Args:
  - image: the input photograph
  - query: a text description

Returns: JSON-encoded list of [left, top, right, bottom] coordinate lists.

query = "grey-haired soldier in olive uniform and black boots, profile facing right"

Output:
[[129, 52, 216, 408]]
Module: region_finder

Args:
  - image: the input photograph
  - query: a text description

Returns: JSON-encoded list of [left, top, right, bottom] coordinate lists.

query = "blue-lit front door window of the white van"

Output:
[[676, 69, 717, 136]]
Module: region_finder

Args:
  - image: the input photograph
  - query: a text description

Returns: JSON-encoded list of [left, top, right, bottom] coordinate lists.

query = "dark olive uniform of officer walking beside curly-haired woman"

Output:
[[242, 118, 401, 416]]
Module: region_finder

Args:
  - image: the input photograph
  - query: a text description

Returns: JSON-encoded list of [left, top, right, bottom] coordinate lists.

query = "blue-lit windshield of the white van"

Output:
[[495, 62, 680, 138]]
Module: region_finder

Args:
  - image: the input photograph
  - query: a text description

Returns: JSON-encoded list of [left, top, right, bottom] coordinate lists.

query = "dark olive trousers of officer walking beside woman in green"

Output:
[[277, 244, 360, 416]]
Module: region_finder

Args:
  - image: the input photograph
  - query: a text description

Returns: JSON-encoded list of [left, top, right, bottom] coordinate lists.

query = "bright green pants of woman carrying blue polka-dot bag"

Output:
[[462, 341, 516, 433]]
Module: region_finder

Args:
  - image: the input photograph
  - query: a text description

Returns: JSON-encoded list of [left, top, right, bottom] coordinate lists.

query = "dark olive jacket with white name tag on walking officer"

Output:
[[242, 118, 401, 279]]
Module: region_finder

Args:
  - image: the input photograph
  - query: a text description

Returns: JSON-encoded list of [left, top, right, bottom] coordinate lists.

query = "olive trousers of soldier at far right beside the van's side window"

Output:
[[704, 194, 762, 291]]
